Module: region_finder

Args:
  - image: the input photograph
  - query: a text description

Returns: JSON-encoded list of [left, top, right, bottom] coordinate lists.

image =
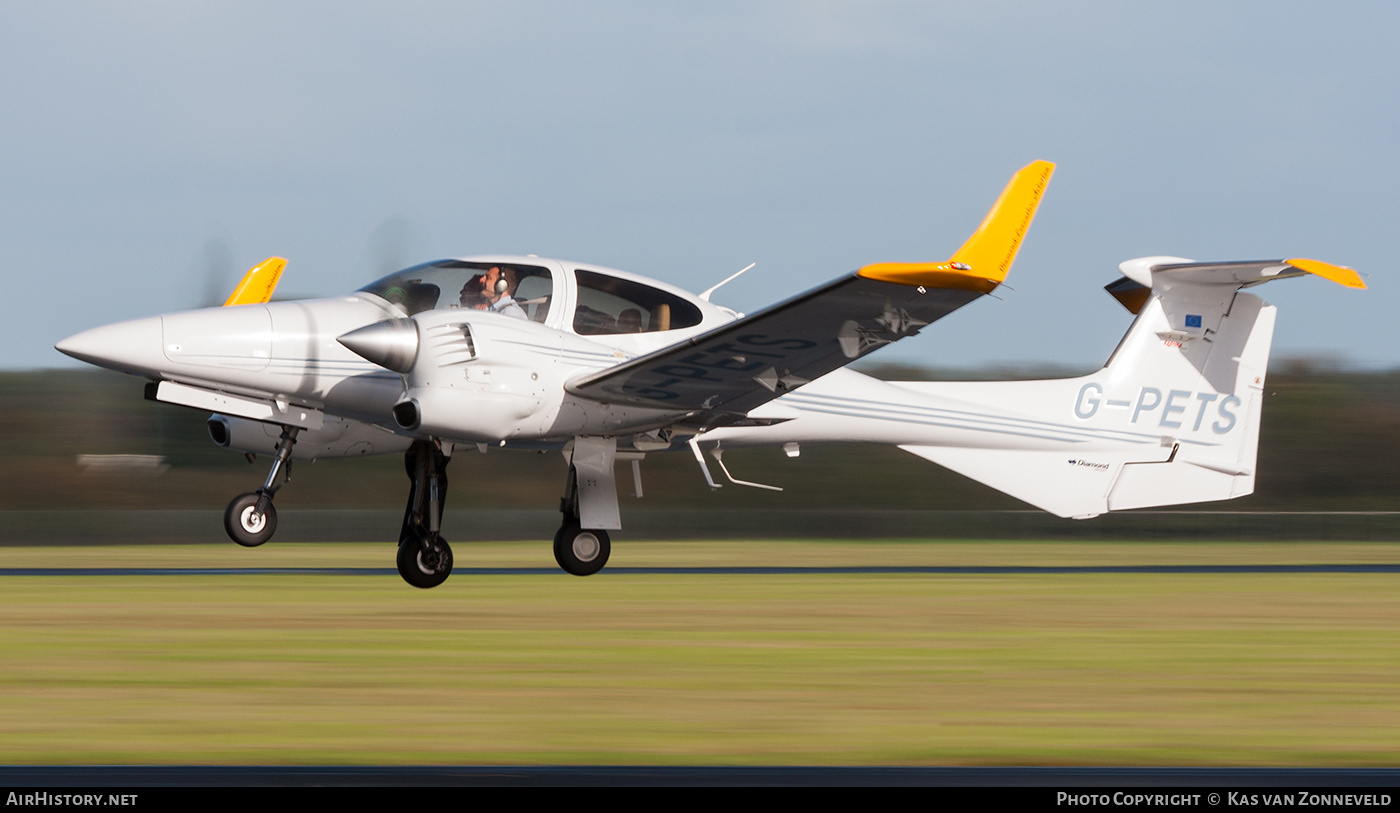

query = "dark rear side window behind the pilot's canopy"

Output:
[[574, 269, 701, 336]]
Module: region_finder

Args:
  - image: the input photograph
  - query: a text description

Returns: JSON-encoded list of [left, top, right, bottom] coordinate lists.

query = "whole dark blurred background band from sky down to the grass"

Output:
[[0, 360, 1400, 543]]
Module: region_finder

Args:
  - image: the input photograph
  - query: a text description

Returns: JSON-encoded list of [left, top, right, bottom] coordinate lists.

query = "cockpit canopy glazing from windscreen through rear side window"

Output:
[[360, 260, 703, 336]]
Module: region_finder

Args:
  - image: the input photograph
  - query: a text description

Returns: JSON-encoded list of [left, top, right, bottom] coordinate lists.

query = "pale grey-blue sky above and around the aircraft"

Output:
[[0, 0, 1400, 369]]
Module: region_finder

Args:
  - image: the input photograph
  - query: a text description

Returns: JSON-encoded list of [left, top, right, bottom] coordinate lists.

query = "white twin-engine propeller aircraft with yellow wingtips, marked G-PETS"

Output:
[[57, 161, 1365, 588]]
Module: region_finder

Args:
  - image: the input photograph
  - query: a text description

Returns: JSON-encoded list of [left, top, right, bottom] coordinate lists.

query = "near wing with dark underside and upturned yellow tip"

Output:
[[567, 161, 1054, 414]]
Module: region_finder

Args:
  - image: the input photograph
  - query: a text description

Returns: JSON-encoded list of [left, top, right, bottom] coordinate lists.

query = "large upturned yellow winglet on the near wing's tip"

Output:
[[857, 161, 1054, 292]]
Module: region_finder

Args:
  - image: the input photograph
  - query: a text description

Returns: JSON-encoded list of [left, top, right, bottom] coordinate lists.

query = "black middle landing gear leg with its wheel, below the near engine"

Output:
[[398, 441, 452, 588]]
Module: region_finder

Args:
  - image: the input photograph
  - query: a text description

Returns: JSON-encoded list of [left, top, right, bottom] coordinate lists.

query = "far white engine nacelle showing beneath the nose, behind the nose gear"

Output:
[[209, 413, 413, 460]]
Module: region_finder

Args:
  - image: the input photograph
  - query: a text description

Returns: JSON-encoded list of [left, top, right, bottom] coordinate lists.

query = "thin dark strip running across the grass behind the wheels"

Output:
[[0, 564, 1400, 577]]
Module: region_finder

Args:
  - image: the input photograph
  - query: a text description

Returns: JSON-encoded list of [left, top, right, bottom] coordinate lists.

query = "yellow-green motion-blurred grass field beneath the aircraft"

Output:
[[0, 542, 1400, 765]]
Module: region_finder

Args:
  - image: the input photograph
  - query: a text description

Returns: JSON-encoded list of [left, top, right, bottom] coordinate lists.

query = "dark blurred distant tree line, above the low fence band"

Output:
[[0, 362, 1400, 511]]
